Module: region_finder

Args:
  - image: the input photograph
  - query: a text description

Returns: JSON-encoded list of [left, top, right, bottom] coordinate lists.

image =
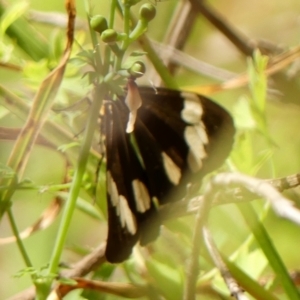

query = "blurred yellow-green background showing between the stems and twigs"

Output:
[[0, 0, 300, 299]]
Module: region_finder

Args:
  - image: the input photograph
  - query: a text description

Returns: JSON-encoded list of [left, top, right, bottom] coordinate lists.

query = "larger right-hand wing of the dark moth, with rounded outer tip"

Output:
[[134, 87, 234, 203]]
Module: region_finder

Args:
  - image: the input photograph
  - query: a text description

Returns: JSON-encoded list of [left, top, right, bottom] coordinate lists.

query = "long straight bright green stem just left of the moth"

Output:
[[48, 85, 105, 287]]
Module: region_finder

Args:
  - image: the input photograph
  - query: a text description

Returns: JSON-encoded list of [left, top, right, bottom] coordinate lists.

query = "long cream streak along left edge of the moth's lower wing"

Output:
[[106, 172, 137, 235]]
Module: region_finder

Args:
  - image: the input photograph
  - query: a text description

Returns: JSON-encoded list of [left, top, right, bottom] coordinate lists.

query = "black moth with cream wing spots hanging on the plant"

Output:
[[101, 81, 235, 263]]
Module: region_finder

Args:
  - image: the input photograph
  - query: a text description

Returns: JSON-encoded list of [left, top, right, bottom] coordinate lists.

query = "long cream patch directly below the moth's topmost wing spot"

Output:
[[184, 123, 208, 172]]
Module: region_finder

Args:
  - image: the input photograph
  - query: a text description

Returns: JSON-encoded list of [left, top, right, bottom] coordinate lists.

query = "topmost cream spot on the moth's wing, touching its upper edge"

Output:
[[181, 92, 203, 124]]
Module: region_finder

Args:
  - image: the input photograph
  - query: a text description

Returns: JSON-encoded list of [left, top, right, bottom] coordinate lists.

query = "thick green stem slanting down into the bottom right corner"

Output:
[[238, 203, 300, 300]]
